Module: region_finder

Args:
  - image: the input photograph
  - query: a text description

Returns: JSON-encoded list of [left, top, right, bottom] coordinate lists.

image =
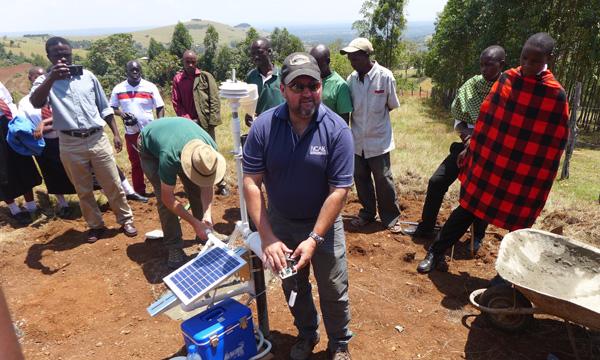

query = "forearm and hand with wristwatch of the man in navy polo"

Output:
[[292, 186, 350, 269]]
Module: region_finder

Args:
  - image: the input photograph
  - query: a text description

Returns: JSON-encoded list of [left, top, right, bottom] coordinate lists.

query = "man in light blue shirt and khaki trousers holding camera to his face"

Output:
[[29, 37, 137, 242]]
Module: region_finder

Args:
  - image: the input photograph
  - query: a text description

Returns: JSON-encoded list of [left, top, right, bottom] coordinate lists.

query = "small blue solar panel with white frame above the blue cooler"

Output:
[[163, 246, 246, 305]]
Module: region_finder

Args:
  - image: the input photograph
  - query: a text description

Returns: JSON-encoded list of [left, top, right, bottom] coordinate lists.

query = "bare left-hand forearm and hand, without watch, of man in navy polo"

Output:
[[244, 174, 292, 271]]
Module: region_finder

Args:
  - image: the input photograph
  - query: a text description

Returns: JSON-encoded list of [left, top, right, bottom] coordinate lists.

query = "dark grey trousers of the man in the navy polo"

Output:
[[268, 207, 352, 350]]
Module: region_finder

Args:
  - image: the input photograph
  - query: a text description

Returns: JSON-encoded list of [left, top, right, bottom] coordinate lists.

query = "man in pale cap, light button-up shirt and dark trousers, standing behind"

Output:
[[340, 38, 402, 233]]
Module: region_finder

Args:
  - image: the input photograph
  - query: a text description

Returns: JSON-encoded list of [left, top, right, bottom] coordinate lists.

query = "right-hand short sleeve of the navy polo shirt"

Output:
[[327, 128, 354, 188]]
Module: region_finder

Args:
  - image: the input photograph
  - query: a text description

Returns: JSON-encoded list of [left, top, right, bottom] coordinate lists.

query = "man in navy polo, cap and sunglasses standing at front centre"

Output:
[[243, 53, 353, 360]]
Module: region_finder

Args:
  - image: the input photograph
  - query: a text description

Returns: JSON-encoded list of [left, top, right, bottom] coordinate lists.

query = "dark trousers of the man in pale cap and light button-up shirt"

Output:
[[354, 153, 400, 227]]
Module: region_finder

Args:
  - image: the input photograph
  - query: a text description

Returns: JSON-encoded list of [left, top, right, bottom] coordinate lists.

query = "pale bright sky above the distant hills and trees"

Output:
[[0, 0, 447, 34]]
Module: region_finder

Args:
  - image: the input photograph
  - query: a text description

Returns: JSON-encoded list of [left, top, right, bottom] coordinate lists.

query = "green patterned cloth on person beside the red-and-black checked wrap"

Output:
[[450, 75, 495, 125]]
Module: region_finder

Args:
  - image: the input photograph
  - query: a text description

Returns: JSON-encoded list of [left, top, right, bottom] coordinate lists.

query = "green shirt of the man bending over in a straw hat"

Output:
[[141, 117, 217, 186]]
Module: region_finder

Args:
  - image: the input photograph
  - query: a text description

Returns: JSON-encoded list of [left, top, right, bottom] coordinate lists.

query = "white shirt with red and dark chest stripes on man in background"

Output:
[[109, 79, 165, 134]]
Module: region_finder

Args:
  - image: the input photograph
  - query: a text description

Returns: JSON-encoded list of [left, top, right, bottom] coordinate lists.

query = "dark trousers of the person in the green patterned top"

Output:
[[419, 142, 487, 239]]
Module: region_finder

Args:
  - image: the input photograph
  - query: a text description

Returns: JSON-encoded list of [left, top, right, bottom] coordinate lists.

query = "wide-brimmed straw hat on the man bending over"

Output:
[[181, 139, 227, 187]]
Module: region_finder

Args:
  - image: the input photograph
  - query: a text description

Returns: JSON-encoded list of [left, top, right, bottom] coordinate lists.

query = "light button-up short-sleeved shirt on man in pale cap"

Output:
[[347, 62, 400, 159]]
